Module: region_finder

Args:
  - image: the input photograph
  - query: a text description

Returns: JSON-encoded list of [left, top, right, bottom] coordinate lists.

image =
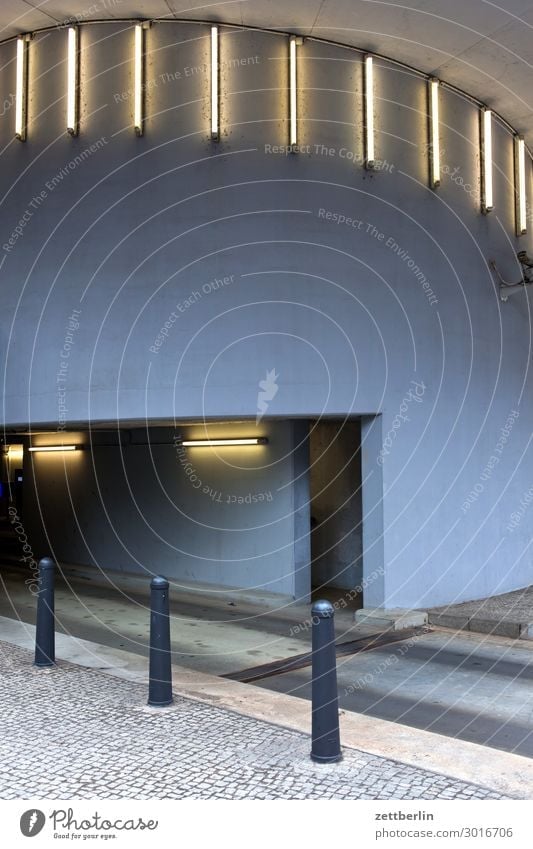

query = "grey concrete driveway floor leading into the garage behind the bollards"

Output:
[[0, 566, 533, 758]]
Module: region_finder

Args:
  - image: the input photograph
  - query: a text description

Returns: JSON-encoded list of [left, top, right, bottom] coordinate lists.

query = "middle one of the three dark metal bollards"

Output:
[[148, 577, 172, 707]]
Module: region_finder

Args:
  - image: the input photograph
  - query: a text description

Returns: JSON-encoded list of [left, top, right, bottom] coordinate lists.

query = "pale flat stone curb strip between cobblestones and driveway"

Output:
[[0, 617, 533, 799]]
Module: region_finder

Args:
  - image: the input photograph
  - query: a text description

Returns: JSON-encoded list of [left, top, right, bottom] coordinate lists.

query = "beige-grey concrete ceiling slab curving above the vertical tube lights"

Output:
[[0, 0, 533, 147]]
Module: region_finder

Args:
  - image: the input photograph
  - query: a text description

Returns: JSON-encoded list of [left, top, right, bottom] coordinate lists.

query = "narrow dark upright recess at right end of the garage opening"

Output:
[[309, 420, 363, 607]]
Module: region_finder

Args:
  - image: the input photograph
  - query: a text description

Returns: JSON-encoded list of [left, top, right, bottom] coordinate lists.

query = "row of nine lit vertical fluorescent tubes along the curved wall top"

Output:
[[15, 23, 527, 235]]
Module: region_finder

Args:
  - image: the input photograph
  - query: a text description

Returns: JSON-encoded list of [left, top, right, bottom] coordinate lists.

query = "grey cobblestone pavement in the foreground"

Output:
[[0, 642, 505, 799]]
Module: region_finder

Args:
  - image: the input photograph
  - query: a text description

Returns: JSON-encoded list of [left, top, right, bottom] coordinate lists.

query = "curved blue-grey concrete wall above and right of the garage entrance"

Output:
[[0, 18, 533, 607]]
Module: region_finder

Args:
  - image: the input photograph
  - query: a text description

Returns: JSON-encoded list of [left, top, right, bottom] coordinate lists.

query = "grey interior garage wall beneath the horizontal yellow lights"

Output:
[[20, 422, 309, 598]]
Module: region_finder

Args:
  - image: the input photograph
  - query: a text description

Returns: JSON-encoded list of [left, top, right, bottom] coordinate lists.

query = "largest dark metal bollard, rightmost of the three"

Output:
[[311, 601, 342, 763]]
